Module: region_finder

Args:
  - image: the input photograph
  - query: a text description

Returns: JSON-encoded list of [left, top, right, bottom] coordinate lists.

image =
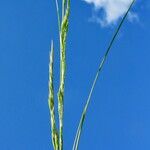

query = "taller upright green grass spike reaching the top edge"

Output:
[[57, 0, 70, 150]]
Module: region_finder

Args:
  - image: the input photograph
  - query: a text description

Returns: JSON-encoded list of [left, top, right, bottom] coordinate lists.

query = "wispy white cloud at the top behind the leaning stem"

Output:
[[83, 0, 138, 25]]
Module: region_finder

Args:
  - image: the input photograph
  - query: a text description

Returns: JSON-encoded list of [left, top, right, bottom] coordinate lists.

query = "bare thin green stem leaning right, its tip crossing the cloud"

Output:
[[73, 0, 135, 150]]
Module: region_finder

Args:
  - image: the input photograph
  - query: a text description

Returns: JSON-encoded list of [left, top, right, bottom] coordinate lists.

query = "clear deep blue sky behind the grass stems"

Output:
[[0, 0, 150, 150]]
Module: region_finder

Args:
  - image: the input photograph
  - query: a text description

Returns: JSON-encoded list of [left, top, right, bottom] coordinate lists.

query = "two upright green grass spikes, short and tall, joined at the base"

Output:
[[49, 0, 70, 150]]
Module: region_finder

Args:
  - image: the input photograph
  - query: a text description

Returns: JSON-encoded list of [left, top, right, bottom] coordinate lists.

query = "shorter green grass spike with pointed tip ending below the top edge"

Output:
[[48, 41, 59, 150]]
